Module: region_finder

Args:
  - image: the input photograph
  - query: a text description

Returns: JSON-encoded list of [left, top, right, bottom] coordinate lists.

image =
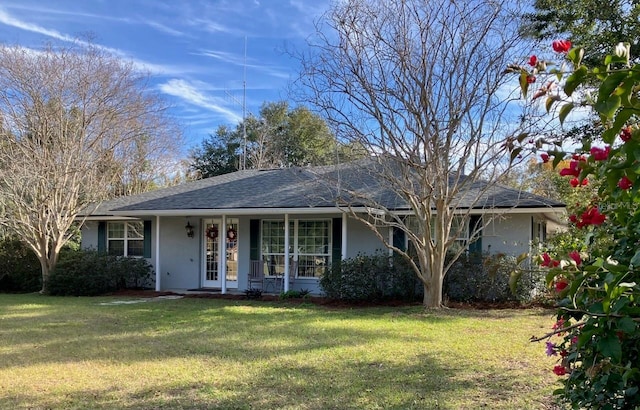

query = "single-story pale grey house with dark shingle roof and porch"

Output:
[[82, 163, 564, 293]]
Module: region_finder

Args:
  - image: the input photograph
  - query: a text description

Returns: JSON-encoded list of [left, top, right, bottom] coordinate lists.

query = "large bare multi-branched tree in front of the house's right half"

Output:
[[299, 0, 527, 307]]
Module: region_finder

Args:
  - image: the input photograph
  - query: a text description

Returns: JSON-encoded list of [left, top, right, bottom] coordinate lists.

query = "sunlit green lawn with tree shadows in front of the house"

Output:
[[0, 295, 558, 409]]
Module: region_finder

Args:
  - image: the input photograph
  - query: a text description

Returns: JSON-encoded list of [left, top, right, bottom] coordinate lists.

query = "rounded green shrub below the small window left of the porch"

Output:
[[48, 250, 151, 296]]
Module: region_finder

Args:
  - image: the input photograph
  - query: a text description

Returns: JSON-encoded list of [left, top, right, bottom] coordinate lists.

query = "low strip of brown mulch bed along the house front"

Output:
[[109, 289, 548, 310]]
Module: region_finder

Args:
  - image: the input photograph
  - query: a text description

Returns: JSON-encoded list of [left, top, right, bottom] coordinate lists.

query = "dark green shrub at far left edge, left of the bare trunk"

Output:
[[0, 237, 42, 292]]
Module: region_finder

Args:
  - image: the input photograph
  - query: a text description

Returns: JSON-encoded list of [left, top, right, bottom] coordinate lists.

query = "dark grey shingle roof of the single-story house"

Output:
[[93, 162, 564, 215]]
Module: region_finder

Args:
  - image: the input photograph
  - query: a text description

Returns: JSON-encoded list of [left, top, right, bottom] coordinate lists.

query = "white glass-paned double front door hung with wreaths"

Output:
[[202, 218, 238, 288]]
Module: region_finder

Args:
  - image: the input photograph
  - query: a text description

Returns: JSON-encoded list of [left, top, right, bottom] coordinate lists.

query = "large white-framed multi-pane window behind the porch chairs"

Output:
[[262, 220, 331, 278]]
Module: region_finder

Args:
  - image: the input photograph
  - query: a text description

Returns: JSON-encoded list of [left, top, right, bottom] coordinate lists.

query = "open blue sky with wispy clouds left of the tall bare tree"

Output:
[[0, 0, 328, 147]]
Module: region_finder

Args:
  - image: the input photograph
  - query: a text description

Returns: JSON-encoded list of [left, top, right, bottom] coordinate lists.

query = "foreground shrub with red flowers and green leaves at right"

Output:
[[510, 40, 640, 409]]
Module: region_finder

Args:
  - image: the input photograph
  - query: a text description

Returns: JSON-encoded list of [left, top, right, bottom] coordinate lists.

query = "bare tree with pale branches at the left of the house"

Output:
[[0, 43, 179, 292]]
